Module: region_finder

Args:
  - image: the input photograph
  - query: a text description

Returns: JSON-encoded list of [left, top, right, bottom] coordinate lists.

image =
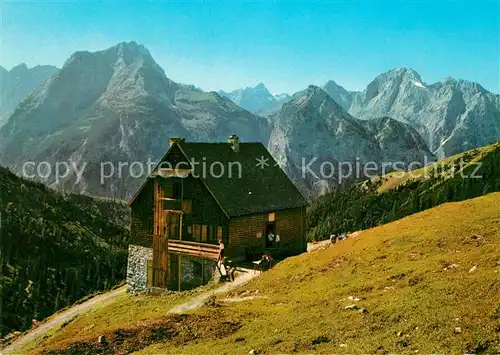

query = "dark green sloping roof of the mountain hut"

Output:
[[176, 141, 307, 217]]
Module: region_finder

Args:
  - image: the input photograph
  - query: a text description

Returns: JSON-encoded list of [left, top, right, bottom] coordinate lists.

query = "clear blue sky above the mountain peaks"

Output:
[[0, 0, 500, 93]]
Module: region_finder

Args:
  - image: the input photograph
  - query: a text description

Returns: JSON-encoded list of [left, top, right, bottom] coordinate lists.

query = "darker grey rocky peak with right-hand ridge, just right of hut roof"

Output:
[[269, 86, 434, 195]]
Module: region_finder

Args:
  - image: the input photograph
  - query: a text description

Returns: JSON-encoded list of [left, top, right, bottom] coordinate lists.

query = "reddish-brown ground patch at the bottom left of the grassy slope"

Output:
[[41, 314, 241, 355]]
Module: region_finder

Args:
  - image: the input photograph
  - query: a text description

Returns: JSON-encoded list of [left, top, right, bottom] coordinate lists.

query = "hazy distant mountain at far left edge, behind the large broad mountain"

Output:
[[0, 63, 58, 121]]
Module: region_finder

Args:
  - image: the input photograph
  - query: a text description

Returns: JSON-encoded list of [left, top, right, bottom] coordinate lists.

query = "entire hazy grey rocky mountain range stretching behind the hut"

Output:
[[0, 42, 500, 198]]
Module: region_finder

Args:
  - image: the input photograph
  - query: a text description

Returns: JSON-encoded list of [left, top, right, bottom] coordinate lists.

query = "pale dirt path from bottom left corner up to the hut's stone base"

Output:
[[0, 286, 126, 355]]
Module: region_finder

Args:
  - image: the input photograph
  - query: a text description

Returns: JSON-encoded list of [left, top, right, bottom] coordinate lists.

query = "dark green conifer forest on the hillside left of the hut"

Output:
[[0, 168, 129, 335]]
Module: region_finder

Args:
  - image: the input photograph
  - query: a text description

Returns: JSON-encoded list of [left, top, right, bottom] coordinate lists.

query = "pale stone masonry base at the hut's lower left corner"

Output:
[[127, 245, 153, 292]]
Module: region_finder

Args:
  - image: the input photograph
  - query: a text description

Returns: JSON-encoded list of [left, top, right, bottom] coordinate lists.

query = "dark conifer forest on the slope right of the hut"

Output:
[[307, 143, 500, 240]]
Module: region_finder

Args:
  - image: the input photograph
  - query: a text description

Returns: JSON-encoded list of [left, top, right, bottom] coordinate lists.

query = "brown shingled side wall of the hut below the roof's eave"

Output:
[[227, 208, 307, 260]]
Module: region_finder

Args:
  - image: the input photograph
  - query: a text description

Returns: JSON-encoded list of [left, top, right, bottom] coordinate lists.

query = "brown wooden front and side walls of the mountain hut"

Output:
[[130, 138, 306, 290]]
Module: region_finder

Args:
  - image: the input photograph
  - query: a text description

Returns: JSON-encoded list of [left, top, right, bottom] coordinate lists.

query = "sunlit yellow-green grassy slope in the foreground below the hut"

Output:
[[33, 193, 500, 354]]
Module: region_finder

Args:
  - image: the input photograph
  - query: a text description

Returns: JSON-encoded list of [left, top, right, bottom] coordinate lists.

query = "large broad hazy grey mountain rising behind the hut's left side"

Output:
[[0, 42, 269, 198]]
